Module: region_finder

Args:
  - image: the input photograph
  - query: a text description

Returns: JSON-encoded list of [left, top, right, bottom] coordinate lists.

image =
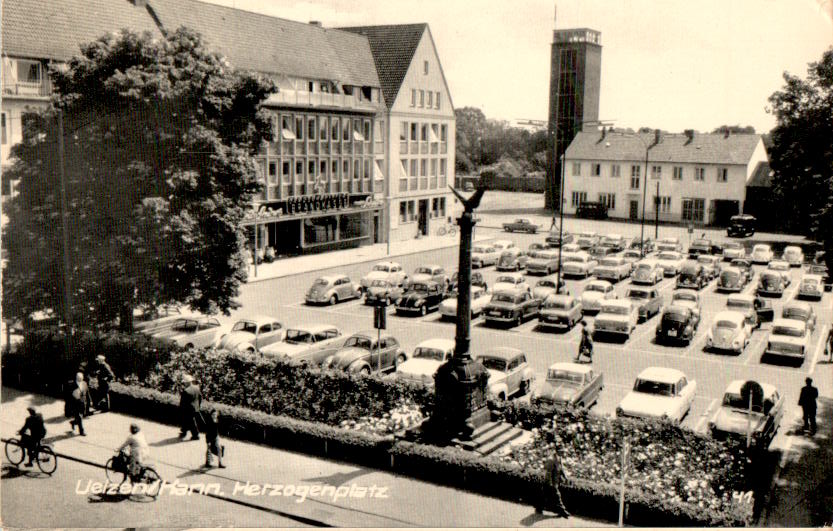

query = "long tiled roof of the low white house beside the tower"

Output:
[[565, 131, 761, 165]]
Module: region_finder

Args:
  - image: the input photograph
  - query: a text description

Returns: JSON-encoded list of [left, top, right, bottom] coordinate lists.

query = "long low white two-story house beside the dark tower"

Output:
[[564, 129, 767, 229]]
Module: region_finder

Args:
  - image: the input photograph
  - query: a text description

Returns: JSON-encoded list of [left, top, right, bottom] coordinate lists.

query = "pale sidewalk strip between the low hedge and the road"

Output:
[[0, 387, 611, 527]]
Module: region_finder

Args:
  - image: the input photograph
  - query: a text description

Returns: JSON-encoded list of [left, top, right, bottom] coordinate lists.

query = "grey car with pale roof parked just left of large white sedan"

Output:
[[530, 362, 604, 409]]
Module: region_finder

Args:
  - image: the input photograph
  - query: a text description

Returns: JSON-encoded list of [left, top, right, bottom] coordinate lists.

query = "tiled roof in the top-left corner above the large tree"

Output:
[[0, 0, 162, 61]]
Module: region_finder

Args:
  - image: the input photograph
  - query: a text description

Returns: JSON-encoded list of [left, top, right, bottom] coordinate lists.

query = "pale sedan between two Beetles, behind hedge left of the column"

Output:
[[260, 324, 345, 367]]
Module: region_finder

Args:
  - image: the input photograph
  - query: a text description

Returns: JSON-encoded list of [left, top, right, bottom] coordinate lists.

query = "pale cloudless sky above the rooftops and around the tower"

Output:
[[208, 0, 833, 133]]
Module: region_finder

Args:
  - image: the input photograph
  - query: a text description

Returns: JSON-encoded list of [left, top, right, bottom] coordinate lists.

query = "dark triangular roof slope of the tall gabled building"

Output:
[[340, 23, 428, 108]]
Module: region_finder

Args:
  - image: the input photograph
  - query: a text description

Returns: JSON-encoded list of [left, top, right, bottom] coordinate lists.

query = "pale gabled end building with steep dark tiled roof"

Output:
[[344, 24, 456, 241]]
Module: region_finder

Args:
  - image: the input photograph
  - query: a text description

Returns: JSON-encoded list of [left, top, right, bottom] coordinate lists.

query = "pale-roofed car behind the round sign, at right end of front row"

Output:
[[709, 380, 784, 450]]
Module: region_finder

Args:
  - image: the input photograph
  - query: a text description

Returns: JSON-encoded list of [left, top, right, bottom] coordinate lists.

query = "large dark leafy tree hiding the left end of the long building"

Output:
[[3, 28, 275, 329]]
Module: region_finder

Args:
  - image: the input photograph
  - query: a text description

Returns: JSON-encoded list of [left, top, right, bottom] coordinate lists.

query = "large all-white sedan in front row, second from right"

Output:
[[616, 367, 697, 424]]
